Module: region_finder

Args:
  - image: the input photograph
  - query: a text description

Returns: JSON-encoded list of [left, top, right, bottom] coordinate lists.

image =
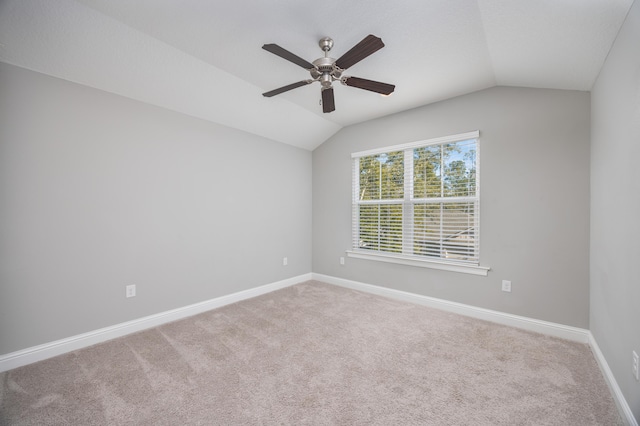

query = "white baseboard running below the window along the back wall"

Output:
[[313, 273, 589, 343]]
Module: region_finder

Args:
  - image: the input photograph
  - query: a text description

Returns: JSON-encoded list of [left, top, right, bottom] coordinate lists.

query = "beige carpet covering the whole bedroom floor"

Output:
[[0, 282, 623, 426]]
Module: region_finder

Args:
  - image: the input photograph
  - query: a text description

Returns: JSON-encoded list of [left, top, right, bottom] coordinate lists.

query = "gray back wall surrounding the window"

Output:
[[313, 87, 590, 328]]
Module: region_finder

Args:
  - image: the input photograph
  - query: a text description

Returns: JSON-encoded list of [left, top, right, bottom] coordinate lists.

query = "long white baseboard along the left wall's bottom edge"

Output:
[[0, 273, 312, 373]]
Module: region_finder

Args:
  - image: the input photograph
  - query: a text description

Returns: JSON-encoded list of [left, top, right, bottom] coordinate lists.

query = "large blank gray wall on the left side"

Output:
[[0, 63, 312, 354]]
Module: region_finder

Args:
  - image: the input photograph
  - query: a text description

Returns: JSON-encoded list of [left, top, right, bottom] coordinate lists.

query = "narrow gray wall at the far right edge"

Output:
[[591, 1, 640, 422]]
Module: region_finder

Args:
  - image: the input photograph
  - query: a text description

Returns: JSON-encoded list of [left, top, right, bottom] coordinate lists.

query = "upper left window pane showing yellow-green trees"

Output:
[[358, 151, 404, 200]]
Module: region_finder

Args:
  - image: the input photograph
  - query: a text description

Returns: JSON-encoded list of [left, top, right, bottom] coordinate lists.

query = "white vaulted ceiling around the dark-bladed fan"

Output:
[[0, 0, 633, 150]]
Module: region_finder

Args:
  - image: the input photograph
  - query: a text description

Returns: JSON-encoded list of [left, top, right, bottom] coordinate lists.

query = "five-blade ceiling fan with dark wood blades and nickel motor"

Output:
[[262, 34, 396, 113]]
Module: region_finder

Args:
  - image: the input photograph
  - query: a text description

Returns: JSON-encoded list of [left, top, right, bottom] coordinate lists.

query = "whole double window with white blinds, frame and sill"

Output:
[[348, 132, 488, 275]]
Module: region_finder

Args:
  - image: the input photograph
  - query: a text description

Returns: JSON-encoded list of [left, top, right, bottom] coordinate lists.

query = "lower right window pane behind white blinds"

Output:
[[413, 202, 476, 260]]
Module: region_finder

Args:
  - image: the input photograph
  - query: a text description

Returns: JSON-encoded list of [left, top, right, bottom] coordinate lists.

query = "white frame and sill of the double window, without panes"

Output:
[[347, 130, 490, 276]]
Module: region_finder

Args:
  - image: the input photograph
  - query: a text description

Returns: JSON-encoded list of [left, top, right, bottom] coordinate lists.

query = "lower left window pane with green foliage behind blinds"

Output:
[[358, 204, 402, 253]]
